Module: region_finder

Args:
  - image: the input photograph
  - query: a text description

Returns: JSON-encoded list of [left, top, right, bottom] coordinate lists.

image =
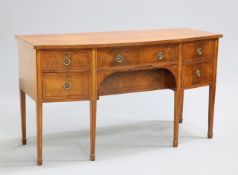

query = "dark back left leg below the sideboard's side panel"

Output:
[[20, 89, 26, 145]]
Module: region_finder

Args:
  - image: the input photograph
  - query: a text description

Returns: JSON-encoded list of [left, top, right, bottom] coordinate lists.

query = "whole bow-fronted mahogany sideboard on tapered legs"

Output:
[[16, 28, 222, 165]]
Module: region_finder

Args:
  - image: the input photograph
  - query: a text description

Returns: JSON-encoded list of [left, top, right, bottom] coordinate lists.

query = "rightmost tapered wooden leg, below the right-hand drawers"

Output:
[[207, 85, 216, 139]]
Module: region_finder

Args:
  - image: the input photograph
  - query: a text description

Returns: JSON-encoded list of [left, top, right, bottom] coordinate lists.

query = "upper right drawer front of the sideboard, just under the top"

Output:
[[183, 40, 215, 61]]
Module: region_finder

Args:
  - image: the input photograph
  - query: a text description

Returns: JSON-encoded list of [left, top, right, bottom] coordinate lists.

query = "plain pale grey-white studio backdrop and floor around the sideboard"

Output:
[[0, 0, 238, 175]]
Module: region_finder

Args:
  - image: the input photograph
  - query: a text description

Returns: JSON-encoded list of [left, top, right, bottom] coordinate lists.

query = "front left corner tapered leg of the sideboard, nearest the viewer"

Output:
[[36, 102, 43, 165]]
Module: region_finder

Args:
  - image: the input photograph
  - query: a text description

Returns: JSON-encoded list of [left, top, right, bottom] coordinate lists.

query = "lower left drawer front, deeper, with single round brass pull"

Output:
[[43, 73, 89, 101]]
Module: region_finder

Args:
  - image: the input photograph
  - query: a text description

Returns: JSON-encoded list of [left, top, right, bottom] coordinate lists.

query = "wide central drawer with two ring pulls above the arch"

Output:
[[97, 44, 178, 68]]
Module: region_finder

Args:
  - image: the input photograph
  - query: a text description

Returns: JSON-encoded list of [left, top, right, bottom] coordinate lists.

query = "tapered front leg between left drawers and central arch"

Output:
[[90, 100, 97, 161]]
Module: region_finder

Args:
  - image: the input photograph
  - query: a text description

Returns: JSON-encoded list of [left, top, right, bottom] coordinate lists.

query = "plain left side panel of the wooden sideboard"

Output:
[[18, 41, 37, 100]]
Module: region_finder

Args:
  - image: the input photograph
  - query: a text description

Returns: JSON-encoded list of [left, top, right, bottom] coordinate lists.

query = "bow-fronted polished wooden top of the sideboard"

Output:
[[16, 28, 222, 49]]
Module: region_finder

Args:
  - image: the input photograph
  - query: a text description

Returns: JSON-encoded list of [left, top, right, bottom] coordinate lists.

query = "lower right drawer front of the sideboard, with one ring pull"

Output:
[[183, 61, 212, 88]]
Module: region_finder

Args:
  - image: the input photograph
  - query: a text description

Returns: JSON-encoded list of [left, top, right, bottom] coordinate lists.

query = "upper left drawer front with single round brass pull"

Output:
[[41, 51, 90, 71]]
